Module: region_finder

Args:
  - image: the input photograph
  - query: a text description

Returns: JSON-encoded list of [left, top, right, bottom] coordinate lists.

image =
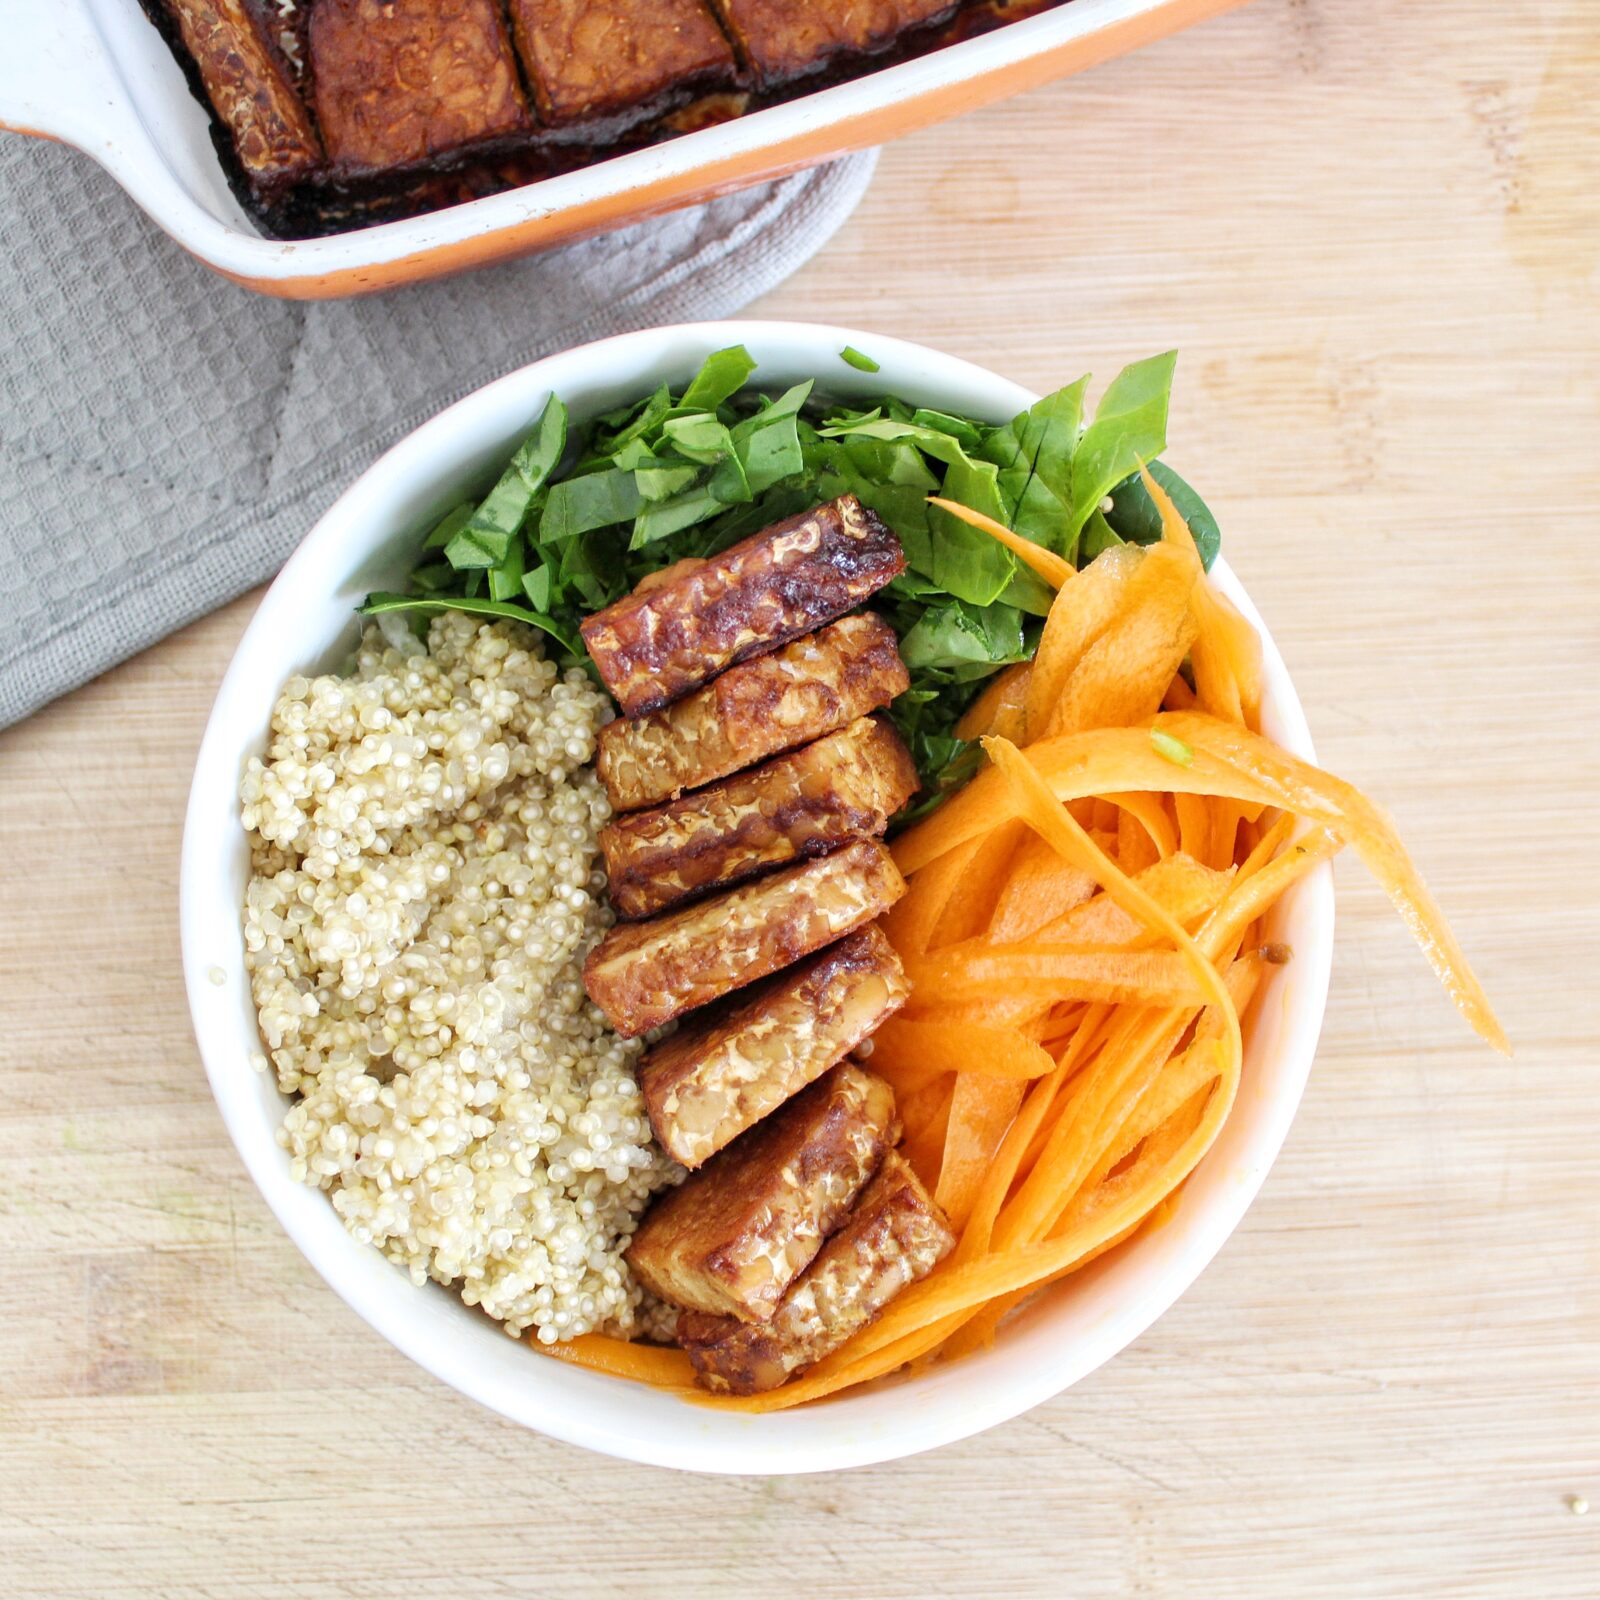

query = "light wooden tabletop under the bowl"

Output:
[[0, 0, 1600, 1600]]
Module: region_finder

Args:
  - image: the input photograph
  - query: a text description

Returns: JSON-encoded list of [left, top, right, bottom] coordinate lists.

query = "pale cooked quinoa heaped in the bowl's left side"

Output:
[[240, 611, 677, 1344]]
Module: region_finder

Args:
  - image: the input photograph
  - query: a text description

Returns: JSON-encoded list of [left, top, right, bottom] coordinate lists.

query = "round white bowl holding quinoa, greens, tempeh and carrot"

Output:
[[179, 322, 1333, 1474]]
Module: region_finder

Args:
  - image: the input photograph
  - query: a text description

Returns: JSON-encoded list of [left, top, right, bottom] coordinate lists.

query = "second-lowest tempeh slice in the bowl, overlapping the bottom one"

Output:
[[627, 1062, 898, 1322]]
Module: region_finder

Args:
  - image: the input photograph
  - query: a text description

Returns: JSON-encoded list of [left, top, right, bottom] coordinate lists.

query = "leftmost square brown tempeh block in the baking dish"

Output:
[[309, 0, 533, 174]]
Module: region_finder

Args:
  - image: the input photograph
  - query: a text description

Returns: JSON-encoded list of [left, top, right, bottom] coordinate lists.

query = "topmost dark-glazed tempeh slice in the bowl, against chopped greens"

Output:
[[581, 494, 906, 717]]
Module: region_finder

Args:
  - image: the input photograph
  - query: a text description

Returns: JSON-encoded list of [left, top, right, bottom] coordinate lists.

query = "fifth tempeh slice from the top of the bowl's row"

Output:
[[638, 928, 910, 1166]]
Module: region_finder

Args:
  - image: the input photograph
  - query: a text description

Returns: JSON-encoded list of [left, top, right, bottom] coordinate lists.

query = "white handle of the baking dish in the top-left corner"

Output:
[[0, 0, 142, 151]]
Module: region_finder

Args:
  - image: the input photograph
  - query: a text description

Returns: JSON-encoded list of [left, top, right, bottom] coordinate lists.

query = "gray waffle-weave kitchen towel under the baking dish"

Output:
[[0, 138, 875, 726]]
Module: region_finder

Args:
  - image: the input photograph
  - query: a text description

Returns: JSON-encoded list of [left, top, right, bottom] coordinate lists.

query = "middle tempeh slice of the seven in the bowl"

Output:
[[584, 840, 906, 1038]]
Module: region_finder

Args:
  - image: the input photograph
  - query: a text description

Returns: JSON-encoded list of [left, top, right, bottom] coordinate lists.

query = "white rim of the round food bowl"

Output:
[[179, 320, 1333, 1474]]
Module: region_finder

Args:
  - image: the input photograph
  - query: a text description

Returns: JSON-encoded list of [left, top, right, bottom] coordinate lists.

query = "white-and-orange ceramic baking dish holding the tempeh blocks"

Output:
[[0, 0, 1240, 299]]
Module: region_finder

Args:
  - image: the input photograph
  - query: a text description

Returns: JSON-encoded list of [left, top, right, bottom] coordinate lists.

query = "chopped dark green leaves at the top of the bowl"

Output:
[[362, 346, 1219, 800]]
